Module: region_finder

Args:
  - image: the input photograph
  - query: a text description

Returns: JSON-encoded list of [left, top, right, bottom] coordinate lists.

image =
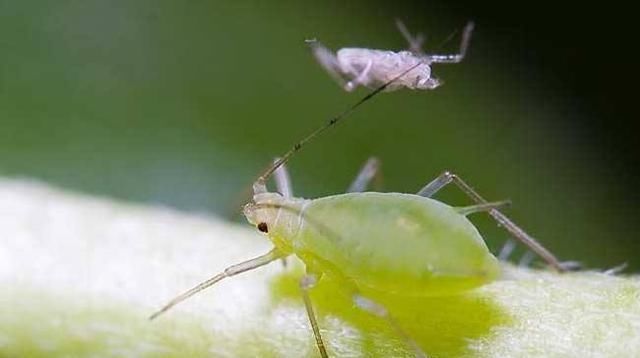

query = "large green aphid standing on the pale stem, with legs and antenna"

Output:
[[150, 59, 564, 357]]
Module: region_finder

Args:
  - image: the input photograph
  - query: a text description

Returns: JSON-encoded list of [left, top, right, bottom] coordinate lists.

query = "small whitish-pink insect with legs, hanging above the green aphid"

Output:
[[307, 21, 473, 91]]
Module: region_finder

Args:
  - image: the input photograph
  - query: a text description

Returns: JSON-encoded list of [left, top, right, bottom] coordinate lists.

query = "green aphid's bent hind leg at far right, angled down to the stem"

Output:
[[418, 172, 566, 272]]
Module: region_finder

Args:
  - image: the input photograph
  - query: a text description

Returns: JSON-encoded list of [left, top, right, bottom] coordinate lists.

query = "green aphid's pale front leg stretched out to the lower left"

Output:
[[149, 248, 283, 319]]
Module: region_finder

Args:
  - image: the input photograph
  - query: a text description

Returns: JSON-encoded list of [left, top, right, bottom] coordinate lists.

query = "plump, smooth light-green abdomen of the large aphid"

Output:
[[292, 193, 499, 295]]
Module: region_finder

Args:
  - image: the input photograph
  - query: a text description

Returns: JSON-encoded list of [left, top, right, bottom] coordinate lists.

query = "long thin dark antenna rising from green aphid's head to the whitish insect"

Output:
[[253, 62, 423, 192]]
